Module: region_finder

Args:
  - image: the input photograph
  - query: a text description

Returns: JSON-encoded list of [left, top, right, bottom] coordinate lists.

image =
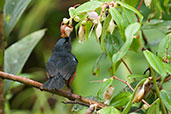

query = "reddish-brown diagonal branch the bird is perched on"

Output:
[[0, 71, 107, 109]]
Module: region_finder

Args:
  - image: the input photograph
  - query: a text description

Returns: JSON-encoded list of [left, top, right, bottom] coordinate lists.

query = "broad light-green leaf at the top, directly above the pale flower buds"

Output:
[[74, 1, 103, 15]]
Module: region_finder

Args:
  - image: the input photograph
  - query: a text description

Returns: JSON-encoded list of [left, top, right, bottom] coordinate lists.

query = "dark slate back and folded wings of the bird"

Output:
[[46, 53, 78, 80]]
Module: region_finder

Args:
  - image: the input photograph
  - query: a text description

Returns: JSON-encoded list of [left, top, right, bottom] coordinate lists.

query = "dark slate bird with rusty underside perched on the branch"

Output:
[[43, 37, 78, 93]]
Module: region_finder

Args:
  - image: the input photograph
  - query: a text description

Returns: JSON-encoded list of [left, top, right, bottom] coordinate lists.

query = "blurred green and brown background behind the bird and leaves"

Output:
[[5, 0, 171, 114]]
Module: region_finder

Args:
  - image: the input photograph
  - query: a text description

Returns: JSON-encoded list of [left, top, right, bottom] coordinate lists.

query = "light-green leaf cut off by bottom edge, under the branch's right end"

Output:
[[99, 107, 120, 114]]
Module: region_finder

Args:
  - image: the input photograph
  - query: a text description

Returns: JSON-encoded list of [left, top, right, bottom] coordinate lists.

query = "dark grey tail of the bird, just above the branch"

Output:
[[43, 76, 65, 90]]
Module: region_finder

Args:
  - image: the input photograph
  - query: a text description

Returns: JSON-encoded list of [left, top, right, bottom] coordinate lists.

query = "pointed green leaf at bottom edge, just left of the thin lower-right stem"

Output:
[[147, 98, 160, 114]]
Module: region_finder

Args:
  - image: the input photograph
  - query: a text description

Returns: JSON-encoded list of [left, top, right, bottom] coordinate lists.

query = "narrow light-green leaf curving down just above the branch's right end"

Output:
[[97, 78, 113, 99]]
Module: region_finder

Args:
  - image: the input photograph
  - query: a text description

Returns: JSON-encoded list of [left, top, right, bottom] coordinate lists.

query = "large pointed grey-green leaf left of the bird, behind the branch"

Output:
[[4, 29, 46, 89]]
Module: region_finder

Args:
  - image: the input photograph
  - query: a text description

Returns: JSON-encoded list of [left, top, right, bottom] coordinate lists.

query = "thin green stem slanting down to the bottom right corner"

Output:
[[150, 66, 167, 114]]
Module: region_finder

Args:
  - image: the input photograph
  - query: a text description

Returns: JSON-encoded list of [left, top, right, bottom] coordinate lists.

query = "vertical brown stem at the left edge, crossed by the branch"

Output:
[[0, 11, 5, 114]]
